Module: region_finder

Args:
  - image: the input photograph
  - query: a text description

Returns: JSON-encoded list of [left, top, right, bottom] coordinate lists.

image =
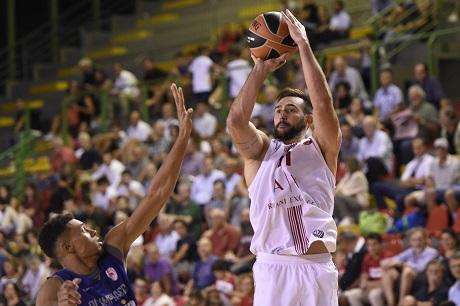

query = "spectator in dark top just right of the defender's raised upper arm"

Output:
[[166, 182, 202, 239]]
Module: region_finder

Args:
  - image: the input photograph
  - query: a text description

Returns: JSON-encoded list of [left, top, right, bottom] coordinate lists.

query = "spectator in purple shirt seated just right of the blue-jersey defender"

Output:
[[144, 243, 178, 295]]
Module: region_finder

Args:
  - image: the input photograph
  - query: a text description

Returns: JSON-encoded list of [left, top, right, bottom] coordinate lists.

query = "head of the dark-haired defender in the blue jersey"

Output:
[[38, 214, 102, 263]]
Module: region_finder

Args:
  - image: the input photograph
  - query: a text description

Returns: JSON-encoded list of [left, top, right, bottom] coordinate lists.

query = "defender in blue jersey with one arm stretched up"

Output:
[[37, 84, 193, 306]]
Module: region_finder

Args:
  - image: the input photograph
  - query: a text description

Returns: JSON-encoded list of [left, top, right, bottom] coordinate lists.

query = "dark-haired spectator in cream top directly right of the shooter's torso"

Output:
[[334, 157, 369, 224]]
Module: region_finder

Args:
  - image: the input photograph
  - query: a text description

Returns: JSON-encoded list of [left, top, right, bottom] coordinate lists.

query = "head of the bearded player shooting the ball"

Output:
[[274, 88, 313, 142]]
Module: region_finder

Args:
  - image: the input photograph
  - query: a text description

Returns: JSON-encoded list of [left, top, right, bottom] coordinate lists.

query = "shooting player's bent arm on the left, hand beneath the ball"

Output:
[[227, 55, 287, 161]]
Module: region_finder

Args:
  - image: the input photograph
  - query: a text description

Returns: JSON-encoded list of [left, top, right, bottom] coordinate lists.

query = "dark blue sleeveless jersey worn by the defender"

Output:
[[54, 246, 136, 306]]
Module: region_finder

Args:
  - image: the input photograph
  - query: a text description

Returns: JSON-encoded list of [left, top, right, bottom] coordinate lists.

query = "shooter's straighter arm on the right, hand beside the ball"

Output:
[[282, 10, 341, 174]]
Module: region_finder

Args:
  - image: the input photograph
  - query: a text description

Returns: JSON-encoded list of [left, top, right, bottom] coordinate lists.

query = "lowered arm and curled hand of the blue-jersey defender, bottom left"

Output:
[[35, 277, 81, 306]]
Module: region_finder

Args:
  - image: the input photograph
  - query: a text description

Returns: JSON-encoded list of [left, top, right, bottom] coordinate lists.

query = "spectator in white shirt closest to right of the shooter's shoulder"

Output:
[[358, 116, 393, 170]]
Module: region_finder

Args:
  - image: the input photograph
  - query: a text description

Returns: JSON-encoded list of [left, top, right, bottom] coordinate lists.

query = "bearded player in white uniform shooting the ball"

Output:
[[227, 10, 341, 306]]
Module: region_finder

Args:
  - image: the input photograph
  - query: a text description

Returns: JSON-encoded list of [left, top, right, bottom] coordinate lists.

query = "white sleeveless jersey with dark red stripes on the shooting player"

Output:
[[248, 137, 337, 255]]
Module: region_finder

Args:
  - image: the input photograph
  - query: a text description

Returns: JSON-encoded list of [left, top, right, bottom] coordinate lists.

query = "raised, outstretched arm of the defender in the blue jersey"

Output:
[[105, 84, 193, 256]]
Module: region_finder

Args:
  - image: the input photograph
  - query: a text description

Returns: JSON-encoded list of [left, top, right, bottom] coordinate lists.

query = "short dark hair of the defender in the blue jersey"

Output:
[[38, 213, 74, 259]]
